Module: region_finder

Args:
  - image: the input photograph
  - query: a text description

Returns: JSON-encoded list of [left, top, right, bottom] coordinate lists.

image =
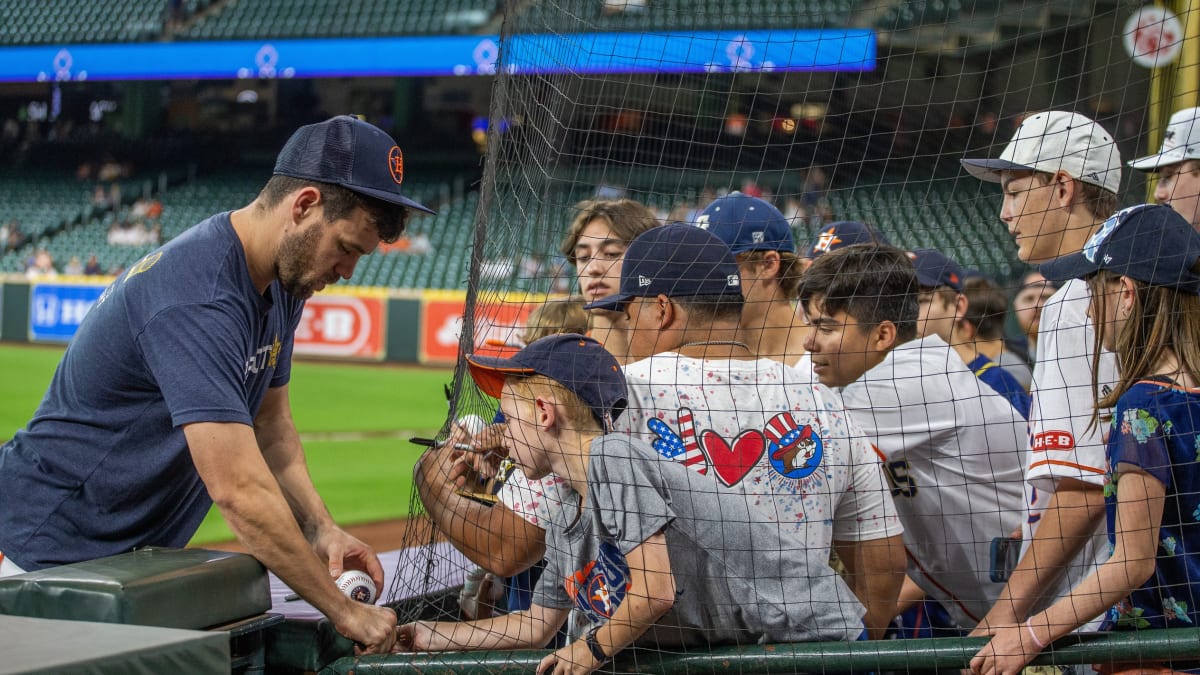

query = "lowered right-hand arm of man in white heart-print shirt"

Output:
[[833, 534, 907, 640]]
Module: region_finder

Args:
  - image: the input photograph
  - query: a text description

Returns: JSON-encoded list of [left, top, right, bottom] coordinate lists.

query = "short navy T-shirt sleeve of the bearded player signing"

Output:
[[136, 304, 255, 426]]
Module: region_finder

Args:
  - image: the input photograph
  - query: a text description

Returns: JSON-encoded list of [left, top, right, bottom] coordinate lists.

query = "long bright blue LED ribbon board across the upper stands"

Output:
[[0, 29, 876, 82]]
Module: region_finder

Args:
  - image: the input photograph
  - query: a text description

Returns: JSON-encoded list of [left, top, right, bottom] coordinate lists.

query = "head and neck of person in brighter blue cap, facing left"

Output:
[[696, 192, 811, 372]]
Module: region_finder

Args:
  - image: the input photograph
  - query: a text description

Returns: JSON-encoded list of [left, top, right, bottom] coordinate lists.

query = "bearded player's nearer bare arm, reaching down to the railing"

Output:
[[184, 422, 396, 653]]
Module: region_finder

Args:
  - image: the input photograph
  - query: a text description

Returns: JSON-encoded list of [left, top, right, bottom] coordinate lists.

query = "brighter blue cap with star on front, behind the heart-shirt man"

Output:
[[696, 192, 796, 255]]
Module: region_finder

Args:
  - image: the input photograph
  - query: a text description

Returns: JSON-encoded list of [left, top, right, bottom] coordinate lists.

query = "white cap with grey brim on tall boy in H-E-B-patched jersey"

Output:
[[959, 110, 1121, 192]]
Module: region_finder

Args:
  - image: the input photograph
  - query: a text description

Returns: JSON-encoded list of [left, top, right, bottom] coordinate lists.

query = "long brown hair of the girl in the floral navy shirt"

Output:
[[1088, 271, 1200, 423]]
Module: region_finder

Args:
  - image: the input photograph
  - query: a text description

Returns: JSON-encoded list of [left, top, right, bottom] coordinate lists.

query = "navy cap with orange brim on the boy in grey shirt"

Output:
[[467, 333, 628, 431]]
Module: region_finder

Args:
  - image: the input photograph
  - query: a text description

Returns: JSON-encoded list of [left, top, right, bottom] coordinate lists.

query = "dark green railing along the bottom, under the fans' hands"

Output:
[[320, 628, 1200, 675]]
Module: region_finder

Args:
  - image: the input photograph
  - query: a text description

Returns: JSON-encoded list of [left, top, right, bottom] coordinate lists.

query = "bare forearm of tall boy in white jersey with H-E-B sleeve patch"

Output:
[[972, 478, 1104, 635]]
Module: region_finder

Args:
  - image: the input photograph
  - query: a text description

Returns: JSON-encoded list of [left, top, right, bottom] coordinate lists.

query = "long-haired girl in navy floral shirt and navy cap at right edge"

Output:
[[971, 204, 1200, 675]]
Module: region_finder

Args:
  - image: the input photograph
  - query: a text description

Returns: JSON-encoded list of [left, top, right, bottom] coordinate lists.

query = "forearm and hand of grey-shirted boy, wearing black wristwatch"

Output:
[[538, 532, 676, 674]]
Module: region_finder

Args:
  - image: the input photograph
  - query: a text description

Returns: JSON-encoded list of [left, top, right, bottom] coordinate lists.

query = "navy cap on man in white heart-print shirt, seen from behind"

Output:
[[583, 222, 742, 311]]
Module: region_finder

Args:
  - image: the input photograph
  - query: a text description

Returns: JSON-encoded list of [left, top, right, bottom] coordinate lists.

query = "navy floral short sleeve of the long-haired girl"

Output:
[[1109, 384, 1171, 489]]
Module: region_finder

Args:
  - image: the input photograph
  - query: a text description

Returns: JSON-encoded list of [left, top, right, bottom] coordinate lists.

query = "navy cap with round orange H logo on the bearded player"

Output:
[[274, 115, 434, 214]]
